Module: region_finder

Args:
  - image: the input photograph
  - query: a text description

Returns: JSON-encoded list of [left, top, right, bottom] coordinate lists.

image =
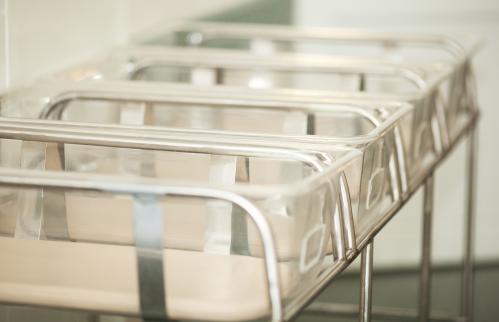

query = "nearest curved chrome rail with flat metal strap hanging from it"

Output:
[[0, 168, 283, 322]]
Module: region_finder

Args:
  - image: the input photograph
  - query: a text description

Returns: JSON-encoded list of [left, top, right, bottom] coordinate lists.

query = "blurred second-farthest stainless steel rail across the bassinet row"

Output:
[[120, 47, 432, 88]]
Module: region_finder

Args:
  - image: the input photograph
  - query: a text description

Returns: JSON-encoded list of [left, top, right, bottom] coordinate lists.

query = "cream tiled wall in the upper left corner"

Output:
[[0, 0, 247, 87]]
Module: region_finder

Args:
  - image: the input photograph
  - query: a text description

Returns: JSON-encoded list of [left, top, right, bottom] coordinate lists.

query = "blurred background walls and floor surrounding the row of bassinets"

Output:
[[0, 0, 499, 321]]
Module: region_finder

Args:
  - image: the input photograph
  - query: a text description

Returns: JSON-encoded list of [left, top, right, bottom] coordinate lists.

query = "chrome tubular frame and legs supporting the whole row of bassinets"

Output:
[[0, 23, 478, 322]]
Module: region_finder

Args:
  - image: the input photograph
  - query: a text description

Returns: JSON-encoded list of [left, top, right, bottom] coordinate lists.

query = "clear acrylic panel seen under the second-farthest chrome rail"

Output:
[[130, 63, 418, 94]]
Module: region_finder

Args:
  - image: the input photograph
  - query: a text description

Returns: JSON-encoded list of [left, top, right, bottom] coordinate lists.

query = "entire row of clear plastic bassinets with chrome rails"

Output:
[[0, 23, 478, 321]]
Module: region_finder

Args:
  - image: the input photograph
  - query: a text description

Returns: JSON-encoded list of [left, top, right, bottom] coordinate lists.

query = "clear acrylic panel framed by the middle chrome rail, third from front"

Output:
[[45, 99, 375, 138]]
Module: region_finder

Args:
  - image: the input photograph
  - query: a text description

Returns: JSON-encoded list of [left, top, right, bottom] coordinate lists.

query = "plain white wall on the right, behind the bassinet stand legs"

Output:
[[294, 0, 499, 265]]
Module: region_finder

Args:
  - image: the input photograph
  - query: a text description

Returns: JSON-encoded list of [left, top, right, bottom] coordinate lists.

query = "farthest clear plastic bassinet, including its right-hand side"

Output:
[[159, 22, 482, 142]]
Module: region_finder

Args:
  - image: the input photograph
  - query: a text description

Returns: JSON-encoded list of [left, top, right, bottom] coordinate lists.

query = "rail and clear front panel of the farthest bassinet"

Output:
[[147, 22, 481, 65]]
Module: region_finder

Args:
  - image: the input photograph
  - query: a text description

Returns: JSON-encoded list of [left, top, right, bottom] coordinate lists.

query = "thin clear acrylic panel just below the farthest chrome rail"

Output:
[[171, 31, 456, 62]]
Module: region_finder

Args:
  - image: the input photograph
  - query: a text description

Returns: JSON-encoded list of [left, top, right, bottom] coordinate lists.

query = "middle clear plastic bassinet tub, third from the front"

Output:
[[2, 82, 414, 251]]
